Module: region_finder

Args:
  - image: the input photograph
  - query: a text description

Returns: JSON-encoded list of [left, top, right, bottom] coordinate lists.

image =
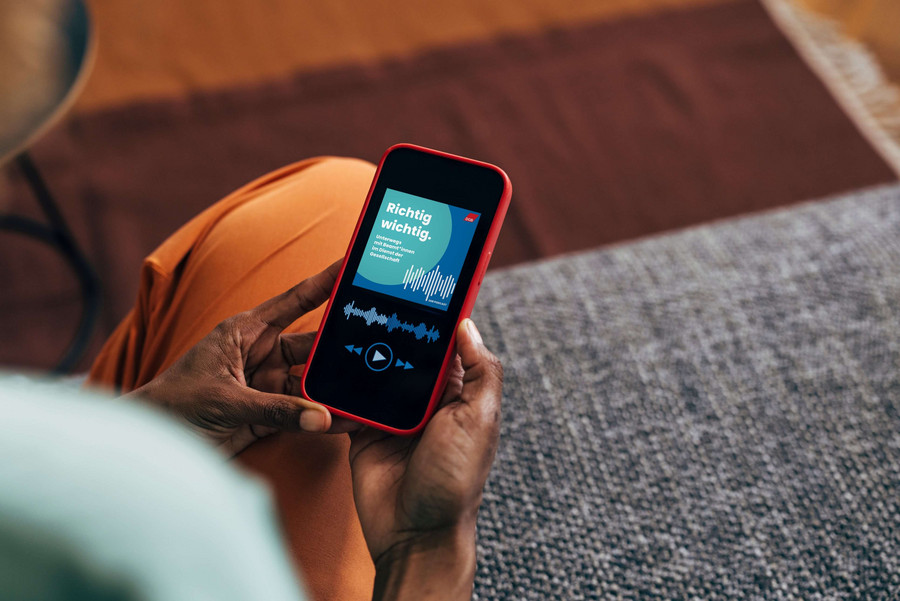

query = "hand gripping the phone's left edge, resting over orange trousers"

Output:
[[129, 262, 357, 455]]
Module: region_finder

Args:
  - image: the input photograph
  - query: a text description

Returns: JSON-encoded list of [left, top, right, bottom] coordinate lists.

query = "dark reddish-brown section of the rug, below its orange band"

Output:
[[0, 0, 896, 367]]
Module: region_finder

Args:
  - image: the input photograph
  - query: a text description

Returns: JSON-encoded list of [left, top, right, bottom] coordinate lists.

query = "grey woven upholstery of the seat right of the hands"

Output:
[[475, 187, 900, 600]]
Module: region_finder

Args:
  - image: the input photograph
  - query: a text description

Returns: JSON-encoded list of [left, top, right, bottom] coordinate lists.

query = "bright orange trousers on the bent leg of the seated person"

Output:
[[89, 157, 375, 601]]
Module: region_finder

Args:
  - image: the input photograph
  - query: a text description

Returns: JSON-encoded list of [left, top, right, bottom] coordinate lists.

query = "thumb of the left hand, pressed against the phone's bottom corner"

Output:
[[233, 388, 331, 432]]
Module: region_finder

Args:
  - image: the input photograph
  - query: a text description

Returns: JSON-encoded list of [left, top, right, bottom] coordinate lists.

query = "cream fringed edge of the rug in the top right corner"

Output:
[[761, 0, 900, 177]]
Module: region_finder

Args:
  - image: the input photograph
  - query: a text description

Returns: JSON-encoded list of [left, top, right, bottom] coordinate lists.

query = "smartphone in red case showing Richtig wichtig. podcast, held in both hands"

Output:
[[303, 144, 512, 435]]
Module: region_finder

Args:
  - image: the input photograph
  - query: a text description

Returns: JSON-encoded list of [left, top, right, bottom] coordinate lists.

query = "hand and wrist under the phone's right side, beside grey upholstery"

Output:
[[350, 319, 503, 599]]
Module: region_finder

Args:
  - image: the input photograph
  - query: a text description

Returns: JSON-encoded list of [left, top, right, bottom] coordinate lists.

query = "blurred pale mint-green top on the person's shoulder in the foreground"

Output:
[[0, 374, 303, 601]]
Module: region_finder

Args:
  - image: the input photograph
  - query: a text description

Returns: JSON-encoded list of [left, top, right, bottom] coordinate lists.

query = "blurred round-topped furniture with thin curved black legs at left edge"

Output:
[[0, 0, 100, 373]]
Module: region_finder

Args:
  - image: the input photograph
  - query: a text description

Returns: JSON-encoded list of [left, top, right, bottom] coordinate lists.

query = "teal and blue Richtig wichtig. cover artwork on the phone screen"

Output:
[[353, 188, 480, 311]]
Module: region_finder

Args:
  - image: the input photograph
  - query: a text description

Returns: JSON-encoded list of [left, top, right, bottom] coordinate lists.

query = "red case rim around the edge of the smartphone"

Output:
[[301, 143, 512, 436]]
